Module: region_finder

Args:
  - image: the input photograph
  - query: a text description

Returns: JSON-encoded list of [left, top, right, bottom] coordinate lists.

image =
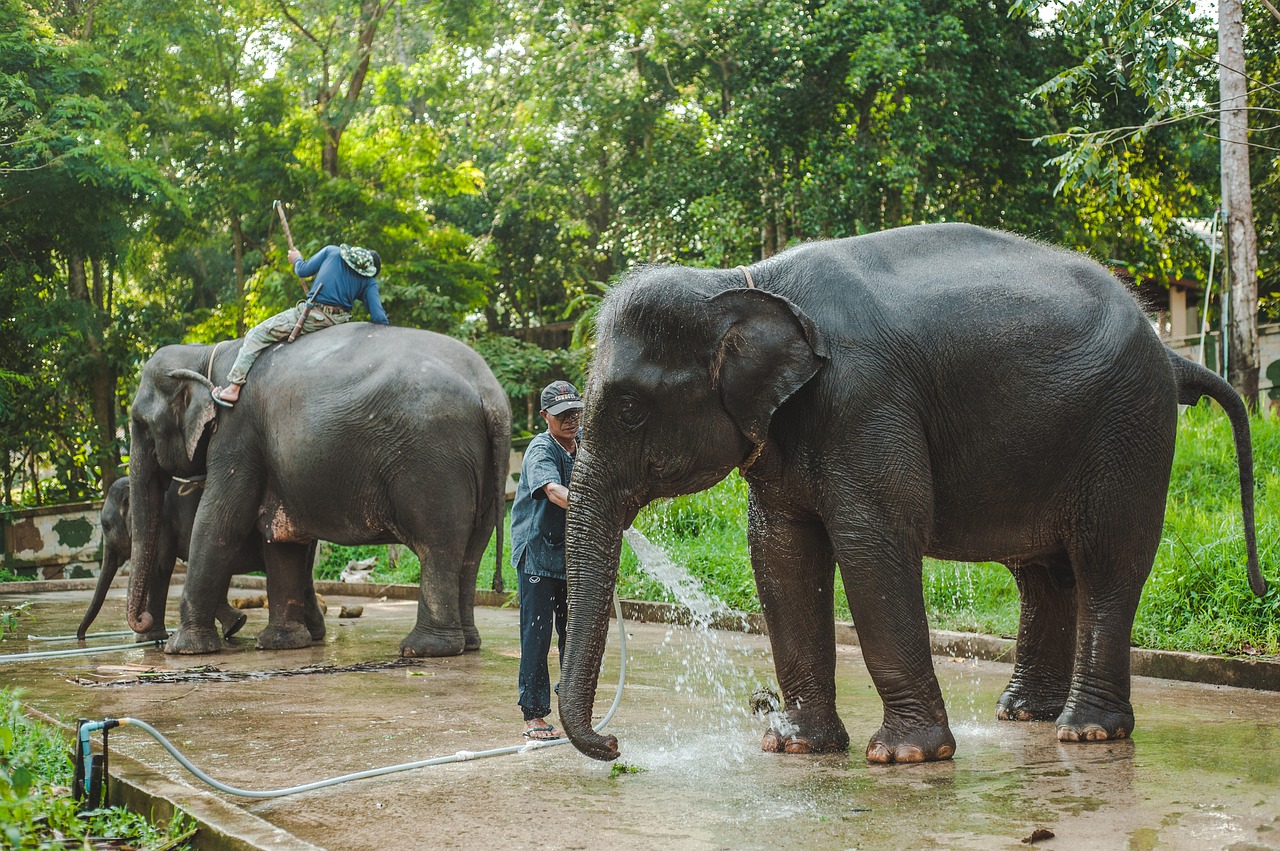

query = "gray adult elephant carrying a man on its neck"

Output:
[[128, 322, 511, 656]]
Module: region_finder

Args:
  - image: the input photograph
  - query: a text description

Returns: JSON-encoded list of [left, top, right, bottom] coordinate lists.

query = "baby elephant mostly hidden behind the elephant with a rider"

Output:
[[76, 476, 298, 641]]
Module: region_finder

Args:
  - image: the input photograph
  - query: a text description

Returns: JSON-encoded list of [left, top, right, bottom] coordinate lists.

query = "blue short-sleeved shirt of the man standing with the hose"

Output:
[[511, 431, 573, 580]]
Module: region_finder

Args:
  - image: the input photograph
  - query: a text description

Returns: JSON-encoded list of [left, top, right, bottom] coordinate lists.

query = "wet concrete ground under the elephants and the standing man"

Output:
[[0, 589, 1280, 850]]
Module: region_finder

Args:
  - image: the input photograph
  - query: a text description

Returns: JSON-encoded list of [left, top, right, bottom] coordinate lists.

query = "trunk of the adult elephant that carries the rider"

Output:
[[125, 435, 169, 632]]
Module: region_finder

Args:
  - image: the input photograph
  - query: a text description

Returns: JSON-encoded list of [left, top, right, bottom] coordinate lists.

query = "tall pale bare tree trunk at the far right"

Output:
[[1217, 0, 1258, 410]]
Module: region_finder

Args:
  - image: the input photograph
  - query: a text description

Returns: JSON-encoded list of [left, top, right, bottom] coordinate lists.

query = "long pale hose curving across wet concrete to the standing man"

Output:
[[76, 594, 627, 799]]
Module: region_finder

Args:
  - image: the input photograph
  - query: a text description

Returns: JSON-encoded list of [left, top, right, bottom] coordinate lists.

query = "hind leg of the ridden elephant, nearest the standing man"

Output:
[[399, 525, 465, 656]]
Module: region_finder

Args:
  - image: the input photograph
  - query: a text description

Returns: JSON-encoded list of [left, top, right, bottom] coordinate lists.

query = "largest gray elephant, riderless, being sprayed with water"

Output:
[[559, 224, 1266, 763]]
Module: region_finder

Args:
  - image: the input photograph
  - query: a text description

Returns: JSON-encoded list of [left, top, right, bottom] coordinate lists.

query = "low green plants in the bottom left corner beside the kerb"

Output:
[[0, 690, 195, 851]]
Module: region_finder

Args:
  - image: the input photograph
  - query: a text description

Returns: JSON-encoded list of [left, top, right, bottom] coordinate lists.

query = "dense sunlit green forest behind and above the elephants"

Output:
[[0, 0, 1280, 504]]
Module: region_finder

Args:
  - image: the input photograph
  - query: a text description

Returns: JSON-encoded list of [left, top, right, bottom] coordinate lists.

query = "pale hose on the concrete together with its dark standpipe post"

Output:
[[72, 594, 627, 810]]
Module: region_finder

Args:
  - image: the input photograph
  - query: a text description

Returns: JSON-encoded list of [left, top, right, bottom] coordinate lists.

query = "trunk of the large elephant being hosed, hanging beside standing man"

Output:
[[559, 448, 623, 760]]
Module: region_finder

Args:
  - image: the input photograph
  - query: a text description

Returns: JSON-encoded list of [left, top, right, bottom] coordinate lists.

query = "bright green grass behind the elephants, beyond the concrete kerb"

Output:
[[316, 404, 1280, 655]]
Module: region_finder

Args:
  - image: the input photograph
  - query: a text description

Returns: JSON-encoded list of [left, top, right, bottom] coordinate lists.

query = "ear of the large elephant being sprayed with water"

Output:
[[710, 289, 827, 443]]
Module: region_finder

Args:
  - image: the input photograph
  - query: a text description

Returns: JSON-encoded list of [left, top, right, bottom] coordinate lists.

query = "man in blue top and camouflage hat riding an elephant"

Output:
[[212, 239, 389, 408]]
